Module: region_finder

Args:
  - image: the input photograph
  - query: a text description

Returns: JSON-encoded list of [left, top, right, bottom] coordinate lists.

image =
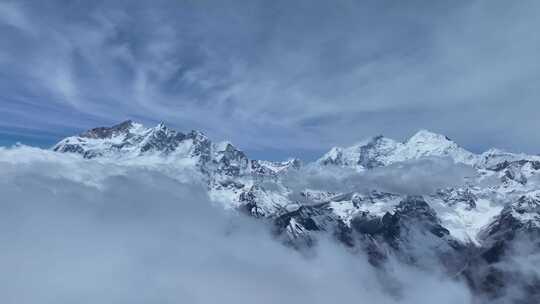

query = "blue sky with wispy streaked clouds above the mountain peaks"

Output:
[[0, 0, 540, 159]]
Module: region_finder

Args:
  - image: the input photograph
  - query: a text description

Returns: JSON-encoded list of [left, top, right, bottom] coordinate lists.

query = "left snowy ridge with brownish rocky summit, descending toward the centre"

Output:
[[52, 120, 300, 176]]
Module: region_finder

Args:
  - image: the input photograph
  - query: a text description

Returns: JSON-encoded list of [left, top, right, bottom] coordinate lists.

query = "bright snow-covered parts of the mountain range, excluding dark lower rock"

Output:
[[52, 121, 540, 242]]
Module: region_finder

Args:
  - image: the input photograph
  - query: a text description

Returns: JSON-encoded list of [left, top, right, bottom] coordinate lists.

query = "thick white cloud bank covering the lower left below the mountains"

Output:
[[0, 147, 470, 304]]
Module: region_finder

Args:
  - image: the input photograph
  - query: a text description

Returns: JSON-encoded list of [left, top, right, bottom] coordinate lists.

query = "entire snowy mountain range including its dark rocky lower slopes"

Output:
[[52, 121, 540, 303]]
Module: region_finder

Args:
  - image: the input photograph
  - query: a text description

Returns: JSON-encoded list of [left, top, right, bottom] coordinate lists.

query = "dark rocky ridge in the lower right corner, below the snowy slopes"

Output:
[[463, 192, 540, 304]]
